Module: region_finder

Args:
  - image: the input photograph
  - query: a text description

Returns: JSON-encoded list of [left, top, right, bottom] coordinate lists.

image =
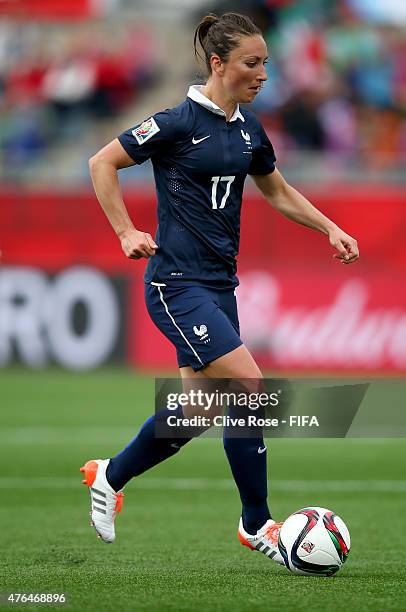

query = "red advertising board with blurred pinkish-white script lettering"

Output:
[[129, 268, 406, 373]]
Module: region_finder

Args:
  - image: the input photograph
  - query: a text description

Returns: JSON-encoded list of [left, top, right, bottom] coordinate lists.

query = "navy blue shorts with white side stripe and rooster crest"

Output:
[[145, 283, 242, 372]]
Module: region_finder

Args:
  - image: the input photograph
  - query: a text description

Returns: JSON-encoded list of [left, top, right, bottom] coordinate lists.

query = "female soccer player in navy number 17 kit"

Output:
[[81, 13, 358, 562]]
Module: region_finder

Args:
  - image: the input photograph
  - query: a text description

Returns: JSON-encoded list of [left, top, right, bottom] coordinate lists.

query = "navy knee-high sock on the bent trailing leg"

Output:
[[106, 406, 197, 491]]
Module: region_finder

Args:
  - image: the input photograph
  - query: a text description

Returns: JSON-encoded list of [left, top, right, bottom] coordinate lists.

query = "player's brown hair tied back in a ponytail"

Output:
[[194, 13, 262, 74]]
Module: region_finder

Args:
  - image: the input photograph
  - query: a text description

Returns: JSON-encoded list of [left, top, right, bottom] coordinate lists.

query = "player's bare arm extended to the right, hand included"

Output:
[[252, 168, 359, 264]]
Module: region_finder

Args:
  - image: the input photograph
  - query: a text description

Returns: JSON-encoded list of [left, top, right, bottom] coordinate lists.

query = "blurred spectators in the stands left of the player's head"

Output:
[[0, 15, 159, 177]]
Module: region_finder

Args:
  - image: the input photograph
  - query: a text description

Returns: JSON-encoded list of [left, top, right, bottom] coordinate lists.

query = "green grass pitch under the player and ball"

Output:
[[0, 368, 406, 612]]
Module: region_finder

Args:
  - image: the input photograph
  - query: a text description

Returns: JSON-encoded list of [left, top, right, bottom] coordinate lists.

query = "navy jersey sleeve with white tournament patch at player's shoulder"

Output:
[[118, 110, 176, 164]]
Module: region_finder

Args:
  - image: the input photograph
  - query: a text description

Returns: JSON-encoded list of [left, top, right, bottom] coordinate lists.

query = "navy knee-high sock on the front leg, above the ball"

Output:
[[223, 407, 271, 534]]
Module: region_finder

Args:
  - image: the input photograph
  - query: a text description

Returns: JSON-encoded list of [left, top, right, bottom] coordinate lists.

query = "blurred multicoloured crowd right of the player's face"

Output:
[[247, 0, 406, 175]]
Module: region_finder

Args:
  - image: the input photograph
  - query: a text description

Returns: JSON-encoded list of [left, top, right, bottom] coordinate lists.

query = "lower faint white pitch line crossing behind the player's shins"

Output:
[[0, 476, 406, 493]]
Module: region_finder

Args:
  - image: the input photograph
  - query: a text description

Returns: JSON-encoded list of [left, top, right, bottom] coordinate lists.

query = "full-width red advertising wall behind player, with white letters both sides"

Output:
[[0, 188, 406, 374]]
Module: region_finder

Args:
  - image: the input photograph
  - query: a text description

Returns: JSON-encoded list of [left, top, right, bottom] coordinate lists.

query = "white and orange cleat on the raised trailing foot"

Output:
[[80, 459, 124, 544]]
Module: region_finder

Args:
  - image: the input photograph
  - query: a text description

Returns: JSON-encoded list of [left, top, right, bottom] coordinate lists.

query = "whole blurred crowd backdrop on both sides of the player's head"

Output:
[[0, 0, 406, 182]]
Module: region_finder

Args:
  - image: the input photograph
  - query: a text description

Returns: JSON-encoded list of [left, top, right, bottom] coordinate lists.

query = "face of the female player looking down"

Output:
[[223, 35, 268, 103]]
